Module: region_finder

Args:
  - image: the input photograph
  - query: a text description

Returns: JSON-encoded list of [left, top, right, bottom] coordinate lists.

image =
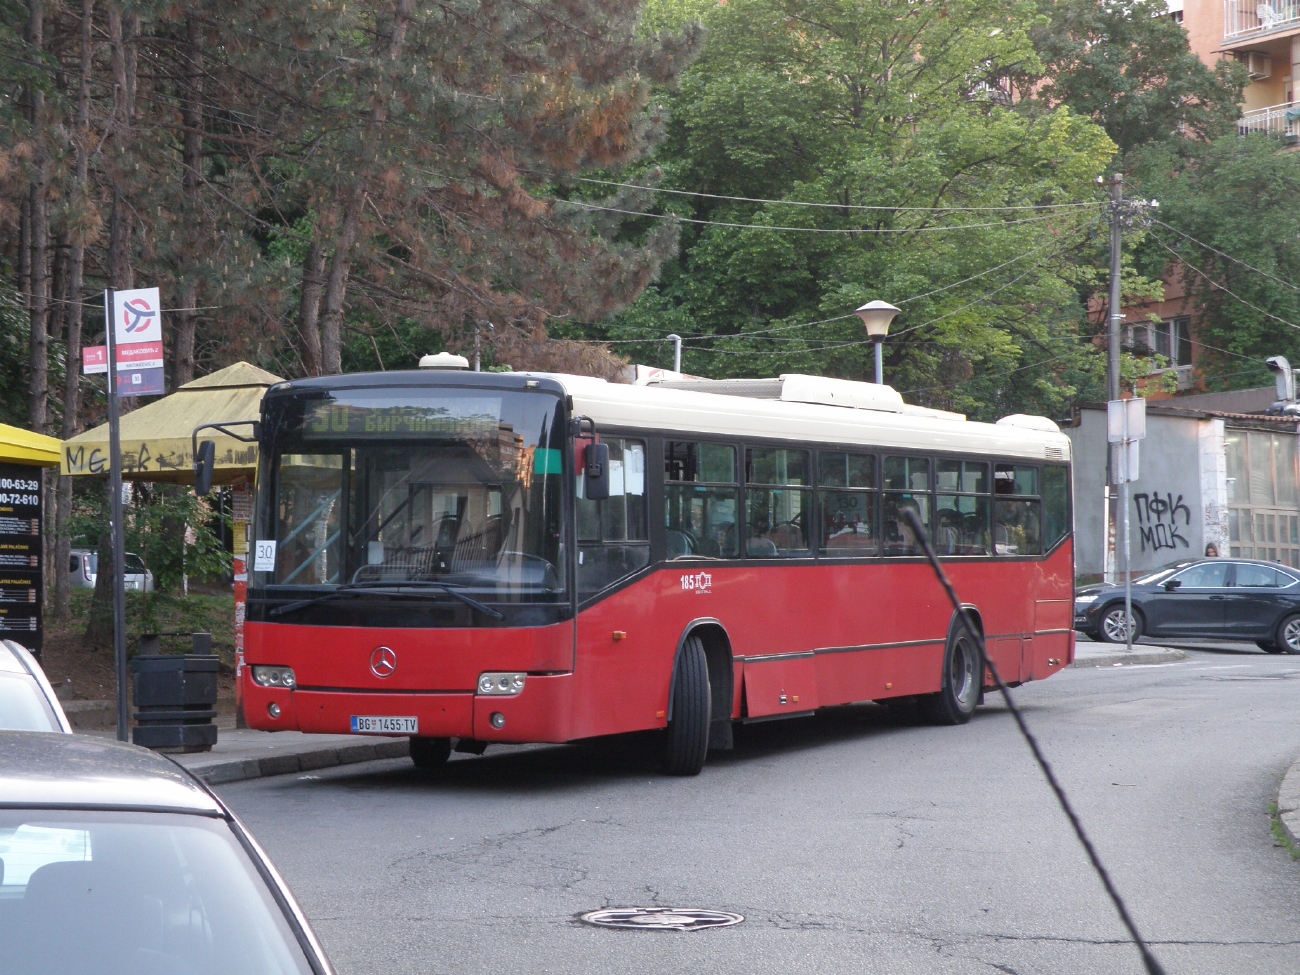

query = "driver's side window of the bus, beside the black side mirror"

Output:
[[575, 439, 650, 595]]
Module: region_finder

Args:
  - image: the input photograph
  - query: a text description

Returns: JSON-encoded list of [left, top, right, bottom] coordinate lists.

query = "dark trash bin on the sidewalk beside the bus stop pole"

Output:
[[131, 633, 220, 751]]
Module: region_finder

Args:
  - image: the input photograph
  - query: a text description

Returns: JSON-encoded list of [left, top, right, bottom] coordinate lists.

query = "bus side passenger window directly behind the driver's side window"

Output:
[[663, 441, 740, 559]]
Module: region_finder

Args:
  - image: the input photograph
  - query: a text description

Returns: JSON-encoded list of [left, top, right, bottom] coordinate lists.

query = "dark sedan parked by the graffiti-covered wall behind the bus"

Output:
[[1074, 559, 1300, 654]]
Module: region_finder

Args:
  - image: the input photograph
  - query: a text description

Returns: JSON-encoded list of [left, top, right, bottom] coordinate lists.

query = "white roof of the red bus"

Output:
[[533, 373, 1070, 460]]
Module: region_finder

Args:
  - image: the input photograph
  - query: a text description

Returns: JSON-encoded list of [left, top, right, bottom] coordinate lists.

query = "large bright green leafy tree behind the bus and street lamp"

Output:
[[585, 0, 1114, 415]]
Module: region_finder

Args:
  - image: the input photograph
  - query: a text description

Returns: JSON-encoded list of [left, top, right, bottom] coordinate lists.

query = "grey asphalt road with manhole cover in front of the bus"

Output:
[[221, 646, 1300, 975]]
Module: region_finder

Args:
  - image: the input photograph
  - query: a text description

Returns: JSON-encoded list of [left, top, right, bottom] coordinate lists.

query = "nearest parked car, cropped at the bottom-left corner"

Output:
[[0, 732, 332, 975]]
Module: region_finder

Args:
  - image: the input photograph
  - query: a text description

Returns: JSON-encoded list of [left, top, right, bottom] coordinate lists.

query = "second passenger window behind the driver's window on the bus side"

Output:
[[745, 447, 813, 559]]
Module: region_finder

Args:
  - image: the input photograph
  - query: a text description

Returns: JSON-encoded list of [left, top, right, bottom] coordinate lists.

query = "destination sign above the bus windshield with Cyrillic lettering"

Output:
[[303, 397, 501, 439]]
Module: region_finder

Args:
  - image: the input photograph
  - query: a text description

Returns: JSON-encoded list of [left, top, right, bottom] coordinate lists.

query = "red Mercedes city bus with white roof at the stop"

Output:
[[242, 369, 1074, 775]]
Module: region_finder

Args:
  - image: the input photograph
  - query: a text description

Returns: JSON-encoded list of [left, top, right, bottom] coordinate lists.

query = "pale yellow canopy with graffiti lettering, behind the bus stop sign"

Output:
[[55, 363, 283, 484]]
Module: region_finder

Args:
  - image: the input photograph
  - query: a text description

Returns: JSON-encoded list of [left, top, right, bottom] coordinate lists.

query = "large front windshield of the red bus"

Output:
[[257, 386, 564, 601]]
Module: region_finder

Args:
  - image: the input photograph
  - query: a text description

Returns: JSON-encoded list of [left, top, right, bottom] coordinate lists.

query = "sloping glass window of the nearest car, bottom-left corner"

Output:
[[0, 809, 312, 975]]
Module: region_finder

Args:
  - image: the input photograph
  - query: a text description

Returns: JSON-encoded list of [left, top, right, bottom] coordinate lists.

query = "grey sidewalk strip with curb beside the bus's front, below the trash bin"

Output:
[[81, 728, 410, 785]]
